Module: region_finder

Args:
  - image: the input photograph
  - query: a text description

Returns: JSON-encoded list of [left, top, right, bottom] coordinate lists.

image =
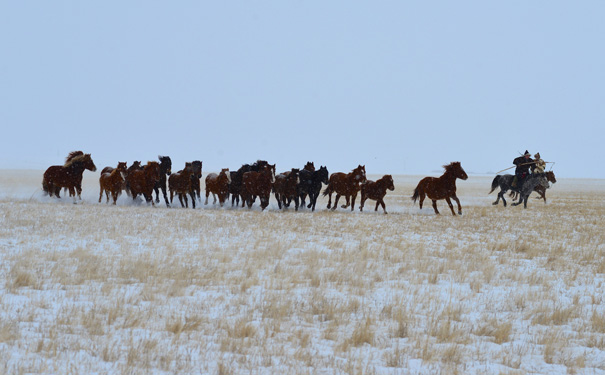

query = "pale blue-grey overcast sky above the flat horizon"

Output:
[[0, 0, 605, 178]]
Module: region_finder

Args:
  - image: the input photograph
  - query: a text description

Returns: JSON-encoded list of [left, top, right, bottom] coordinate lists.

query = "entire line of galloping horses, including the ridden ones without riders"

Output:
[[42, 151, 556, 216]]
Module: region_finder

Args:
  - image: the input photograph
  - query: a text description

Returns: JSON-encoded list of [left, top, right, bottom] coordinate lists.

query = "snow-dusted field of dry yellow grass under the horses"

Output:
[[0, 170, 605, 375]]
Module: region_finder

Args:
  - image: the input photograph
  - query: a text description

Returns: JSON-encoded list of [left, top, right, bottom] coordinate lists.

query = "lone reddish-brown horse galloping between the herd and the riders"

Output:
[[412, 161, 468, 216]]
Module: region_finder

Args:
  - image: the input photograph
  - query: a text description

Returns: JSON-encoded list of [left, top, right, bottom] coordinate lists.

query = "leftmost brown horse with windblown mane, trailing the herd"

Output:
[[42, 151, 97, 202]]
